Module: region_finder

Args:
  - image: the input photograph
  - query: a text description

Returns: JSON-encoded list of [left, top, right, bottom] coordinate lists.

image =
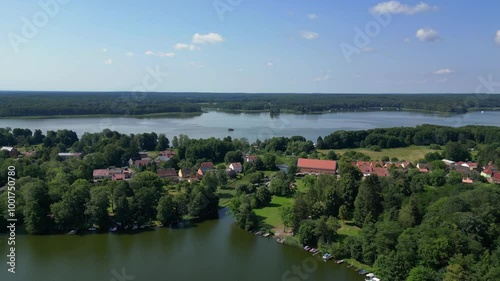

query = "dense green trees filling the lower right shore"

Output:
[[281, 161, 500, 281]]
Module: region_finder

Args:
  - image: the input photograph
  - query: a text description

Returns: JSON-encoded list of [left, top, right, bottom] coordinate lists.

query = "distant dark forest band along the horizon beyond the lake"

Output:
[[0, 92, 500, 117]]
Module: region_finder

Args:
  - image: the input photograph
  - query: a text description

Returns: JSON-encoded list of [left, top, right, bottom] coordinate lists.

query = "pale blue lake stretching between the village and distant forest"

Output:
[[0, 111, 500, 141]]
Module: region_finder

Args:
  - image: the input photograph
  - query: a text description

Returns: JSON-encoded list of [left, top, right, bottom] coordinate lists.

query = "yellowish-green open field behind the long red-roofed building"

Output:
[[319, 146, 434, 162]]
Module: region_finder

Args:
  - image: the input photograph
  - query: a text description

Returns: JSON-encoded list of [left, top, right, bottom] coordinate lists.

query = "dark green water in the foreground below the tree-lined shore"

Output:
[[0, 210, 363, 281]]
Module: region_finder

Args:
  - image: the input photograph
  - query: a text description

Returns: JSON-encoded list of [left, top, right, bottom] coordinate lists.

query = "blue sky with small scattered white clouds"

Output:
[[0, 0, 500, 93]]
